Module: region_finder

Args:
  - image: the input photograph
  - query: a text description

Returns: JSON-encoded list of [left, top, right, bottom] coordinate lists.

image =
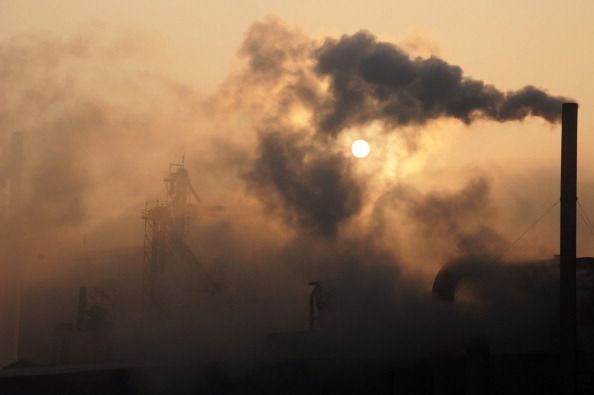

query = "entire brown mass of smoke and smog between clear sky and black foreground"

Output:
[[0, 18, 590, 393]]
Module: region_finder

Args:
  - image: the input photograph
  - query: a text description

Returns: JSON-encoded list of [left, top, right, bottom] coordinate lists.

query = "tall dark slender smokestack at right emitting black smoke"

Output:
[[560, 103, 578, 395]]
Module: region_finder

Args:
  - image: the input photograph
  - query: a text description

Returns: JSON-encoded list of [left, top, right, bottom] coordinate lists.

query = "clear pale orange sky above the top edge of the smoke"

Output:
[[0, 0, 594, 92]]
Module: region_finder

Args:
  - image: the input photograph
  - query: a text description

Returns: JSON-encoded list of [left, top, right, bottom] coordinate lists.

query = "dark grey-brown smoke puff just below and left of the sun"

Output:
[[247, 127, 363, 237]]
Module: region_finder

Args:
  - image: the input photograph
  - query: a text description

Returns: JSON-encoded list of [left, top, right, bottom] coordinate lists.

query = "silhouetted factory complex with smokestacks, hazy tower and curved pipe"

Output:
[[0, 103, 594, 395]]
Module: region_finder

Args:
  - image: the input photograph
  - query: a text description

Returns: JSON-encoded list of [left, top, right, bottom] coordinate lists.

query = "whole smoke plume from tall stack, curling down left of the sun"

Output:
[[230, 19, 566, 237]]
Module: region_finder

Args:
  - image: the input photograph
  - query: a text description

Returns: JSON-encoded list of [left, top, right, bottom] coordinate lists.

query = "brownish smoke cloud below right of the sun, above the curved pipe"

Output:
[[370, 177, 509, 278]]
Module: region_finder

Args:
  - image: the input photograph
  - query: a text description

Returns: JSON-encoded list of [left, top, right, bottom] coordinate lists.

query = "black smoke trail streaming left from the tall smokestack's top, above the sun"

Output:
[[316, 32, 567, 135]]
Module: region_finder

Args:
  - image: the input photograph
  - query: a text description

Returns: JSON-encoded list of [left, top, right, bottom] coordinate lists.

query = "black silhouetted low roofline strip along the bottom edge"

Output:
[[0, 356, 580, 395]]
